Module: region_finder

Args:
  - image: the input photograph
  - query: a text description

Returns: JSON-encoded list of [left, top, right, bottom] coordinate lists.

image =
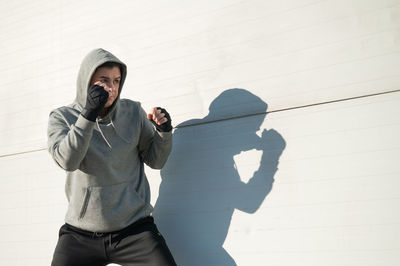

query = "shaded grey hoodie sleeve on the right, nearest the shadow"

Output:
[[139, 106, 172, 169]]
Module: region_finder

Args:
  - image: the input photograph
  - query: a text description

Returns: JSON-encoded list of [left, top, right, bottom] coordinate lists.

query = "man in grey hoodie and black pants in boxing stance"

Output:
[[48, 49, 176, 266]]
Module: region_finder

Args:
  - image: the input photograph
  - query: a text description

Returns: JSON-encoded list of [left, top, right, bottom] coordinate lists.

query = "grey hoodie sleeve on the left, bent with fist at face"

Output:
[[47, 111, 95, 171]]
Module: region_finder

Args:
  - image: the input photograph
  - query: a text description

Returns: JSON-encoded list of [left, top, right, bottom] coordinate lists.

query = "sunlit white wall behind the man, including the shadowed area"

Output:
[[0, 0, 400, 266]]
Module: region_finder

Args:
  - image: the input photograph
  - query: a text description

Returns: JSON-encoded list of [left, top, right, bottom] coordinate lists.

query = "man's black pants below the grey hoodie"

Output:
[[51, 217, 176, 266]]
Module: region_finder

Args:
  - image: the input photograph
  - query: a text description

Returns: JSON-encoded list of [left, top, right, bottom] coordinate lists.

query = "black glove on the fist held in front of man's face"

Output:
[[82, 85, 108, 122]]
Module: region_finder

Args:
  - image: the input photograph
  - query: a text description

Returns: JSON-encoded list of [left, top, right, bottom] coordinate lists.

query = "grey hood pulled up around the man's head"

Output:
[[74, 48, 127, 117]]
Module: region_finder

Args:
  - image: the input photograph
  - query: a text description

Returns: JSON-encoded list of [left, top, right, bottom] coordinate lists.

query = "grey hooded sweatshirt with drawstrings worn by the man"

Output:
[[48, 49, 172, 232]]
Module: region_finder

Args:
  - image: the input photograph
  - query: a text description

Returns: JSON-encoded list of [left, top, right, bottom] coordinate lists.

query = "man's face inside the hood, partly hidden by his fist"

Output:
[[90, 67, 121, 108]]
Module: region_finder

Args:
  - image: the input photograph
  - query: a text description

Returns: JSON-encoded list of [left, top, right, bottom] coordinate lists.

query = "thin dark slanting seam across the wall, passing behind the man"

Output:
[[0, 89, 400, 158]]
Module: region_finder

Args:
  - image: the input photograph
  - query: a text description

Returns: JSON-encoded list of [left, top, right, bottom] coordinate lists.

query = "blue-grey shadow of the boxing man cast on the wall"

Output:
[[153, 89, 286, 266]]
